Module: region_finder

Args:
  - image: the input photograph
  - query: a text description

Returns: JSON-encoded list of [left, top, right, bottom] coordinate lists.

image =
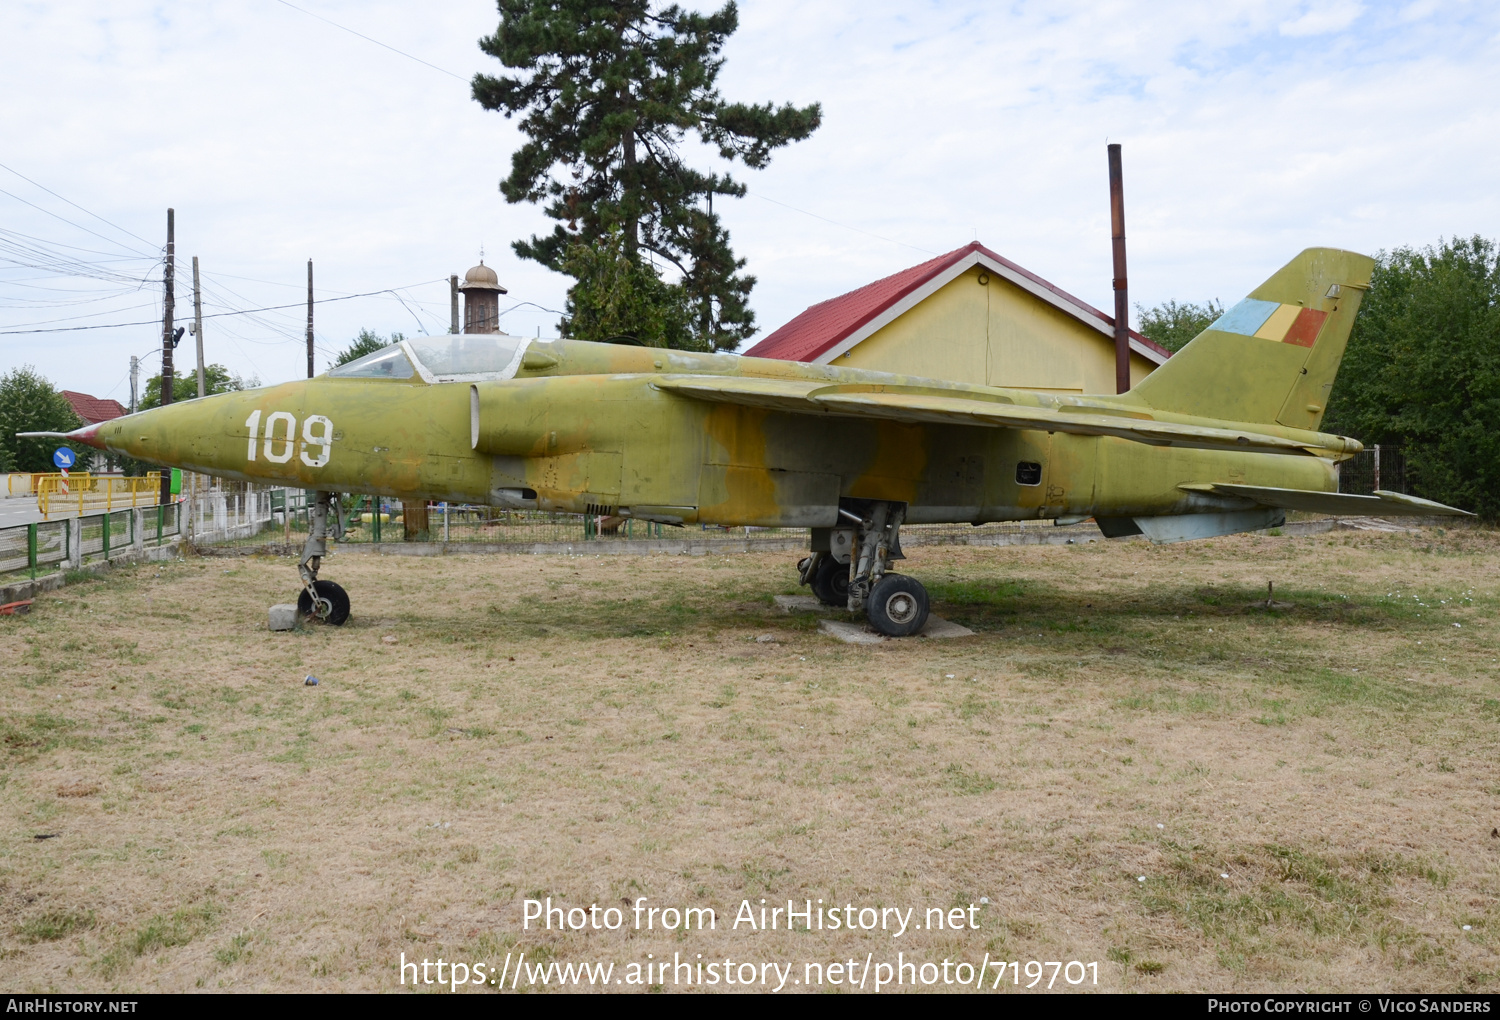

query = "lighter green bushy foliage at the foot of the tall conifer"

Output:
[[563, 230, 696, 351]]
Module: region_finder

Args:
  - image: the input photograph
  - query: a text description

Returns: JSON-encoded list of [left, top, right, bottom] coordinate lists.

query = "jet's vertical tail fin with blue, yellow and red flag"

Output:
[[1131, 248, 1376, 431]]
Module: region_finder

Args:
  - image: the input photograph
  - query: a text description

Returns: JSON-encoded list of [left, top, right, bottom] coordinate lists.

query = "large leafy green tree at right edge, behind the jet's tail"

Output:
[[1323, 237, 1500, 521]]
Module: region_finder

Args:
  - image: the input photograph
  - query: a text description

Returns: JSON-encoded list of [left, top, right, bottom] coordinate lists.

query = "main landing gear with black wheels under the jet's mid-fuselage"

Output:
[[798, 500, 927, 638]]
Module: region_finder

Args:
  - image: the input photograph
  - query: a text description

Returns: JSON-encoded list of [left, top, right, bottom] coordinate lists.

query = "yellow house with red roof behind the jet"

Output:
[[746, 242, 1172, 393]]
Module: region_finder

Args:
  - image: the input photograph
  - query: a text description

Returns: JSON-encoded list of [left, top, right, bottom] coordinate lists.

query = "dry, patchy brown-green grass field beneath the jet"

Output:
[[0, 528, 1500, 993]]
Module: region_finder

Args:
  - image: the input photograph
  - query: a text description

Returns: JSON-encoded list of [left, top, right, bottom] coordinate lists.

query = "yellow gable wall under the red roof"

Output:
[[834, 267, 1157, 393]]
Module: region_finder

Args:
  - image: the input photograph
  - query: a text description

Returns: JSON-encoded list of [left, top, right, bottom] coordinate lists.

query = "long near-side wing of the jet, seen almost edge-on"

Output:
[[656, 375, 1344, 456]]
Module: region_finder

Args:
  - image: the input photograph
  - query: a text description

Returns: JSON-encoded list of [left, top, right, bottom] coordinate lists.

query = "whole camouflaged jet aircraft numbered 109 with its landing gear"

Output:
[[26, 249, 1472, 636]]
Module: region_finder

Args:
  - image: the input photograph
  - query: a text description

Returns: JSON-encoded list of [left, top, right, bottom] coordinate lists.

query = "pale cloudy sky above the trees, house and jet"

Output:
[[0, 0, 1500, 402]]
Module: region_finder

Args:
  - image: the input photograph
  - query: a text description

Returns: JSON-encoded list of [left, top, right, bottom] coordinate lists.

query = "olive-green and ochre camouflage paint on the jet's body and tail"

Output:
[[84, 249, 1370, 527]]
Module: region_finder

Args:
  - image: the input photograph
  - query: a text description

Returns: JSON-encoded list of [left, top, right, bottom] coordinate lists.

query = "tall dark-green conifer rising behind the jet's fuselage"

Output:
[[474, 0, 822, 350]]
